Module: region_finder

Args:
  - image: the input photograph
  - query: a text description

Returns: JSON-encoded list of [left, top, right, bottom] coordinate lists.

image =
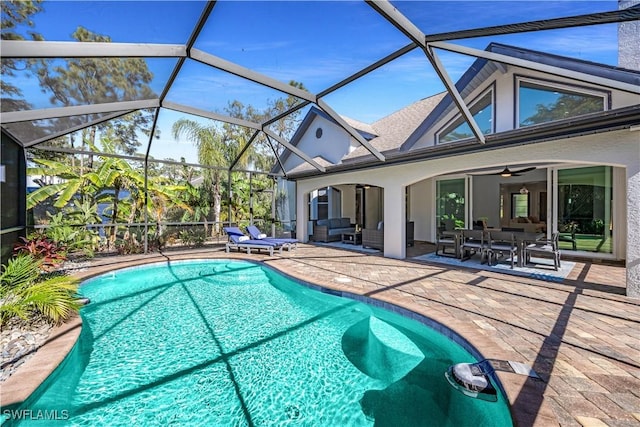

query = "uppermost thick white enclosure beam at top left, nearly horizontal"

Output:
[[0, 40, 187, 59]]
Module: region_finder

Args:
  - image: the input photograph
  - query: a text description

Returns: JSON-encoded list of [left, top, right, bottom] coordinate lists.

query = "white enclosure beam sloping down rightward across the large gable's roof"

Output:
[[429, 42, 640, 94]]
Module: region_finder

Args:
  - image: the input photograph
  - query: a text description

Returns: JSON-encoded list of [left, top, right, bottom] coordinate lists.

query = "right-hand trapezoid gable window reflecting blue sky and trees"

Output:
[[518, 80, 607, 127]]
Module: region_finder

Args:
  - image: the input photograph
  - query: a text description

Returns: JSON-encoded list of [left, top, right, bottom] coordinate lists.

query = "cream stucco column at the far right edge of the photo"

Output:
[[626, 162, 640, 298]]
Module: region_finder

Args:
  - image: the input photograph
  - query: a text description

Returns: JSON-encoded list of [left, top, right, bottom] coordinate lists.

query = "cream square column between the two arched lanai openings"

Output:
[[384, 184, 407, 259]]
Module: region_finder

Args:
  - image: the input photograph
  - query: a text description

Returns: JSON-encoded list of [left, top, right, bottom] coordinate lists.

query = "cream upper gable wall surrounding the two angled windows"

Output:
[[412, 66, 638, 149]]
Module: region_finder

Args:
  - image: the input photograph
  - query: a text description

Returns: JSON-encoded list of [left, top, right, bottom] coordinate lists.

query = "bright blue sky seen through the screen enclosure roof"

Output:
[[10, 0, 618, 162]]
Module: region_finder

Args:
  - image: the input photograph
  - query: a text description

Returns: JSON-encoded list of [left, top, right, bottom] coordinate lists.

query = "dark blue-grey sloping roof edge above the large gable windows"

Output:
[[400, 43, 640, 151]]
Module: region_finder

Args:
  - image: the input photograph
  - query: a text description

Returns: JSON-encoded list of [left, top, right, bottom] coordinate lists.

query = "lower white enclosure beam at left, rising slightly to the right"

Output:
[[0, 99, 160, 124]]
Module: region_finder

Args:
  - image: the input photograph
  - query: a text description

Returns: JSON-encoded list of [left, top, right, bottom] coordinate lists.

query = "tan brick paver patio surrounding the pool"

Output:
[[2, 244, 640, 426]]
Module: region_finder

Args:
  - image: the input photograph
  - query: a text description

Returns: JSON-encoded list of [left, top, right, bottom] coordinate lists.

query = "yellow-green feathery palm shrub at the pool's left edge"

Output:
[[0, 254, 80, 325]]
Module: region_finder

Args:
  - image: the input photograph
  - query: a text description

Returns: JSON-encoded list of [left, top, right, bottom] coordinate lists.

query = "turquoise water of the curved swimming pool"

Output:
[[8, 260, 512, 427]]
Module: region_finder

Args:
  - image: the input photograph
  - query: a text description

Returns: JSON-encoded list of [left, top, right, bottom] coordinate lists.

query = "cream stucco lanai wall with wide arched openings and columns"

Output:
[[297, 130, 640, 297]]
